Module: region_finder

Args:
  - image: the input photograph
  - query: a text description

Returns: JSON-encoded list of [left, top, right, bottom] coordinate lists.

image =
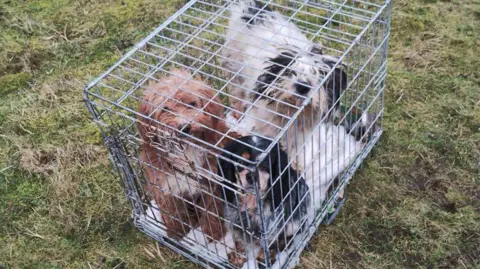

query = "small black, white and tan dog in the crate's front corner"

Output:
[[218, 136, 311, 268]]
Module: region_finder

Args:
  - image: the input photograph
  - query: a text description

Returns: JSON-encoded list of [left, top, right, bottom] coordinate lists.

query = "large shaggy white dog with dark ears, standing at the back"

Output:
[[222, 0, 354, 165]]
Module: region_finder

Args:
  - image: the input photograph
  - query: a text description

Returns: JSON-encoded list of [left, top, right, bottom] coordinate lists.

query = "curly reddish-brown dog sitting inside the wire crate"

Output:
[[138, 70, 232, 241]]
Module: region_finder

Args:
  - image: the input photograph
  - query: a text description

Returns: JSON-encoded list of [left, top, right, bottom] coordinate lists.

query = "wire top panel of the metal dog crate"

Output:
[[85, 0, 387, 165]]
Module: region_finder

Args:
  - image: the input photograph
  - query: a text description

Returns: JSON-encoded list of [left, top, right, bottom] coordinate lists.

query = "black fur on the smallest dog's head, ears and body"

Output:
[[218, 136, 310, 236]]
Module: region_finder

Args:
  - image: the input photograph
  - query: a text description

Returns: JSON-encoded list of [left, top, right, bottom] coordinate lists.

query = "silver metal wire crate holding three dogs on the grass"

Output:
[[84, 0, 391, 268]]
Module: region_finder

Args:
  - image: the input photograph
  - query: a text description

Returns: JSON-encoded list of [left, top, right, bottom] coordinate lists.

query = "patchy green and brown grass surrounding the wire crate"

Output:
[[0, 0, 480, 269]]
